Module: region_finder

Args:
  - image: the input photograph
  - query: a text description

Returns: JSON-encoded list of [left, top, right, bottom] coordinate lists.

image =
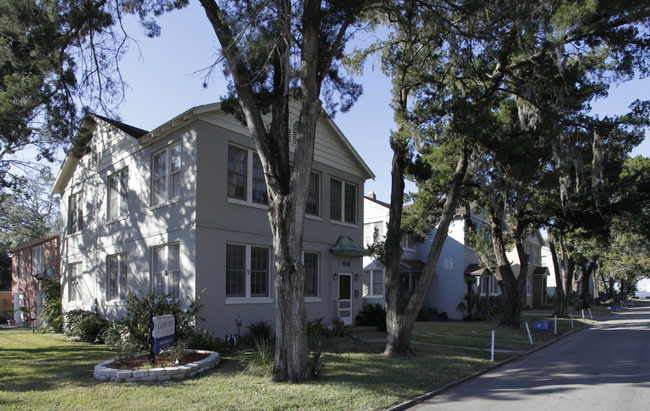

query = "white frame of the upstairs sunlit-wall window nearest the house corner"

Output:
[[151, 141, 183, 207]]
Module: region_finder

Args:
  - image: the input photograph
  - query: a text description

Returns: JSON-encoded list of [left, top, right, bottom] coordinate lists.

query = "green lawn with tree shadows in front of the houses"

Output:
[[0, 314, 588, 410]]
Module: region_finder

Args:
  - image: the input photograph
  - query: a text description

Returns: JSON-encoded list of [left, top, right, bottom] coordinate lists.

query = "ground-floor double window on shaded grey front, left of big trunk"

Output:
[[226, 244, 270, 298]]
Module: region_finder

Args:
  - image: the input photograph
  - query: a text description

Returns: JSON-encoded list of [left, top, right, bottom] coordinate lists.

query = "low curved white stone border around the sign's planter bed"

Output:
[[94, 350, 221, 382]]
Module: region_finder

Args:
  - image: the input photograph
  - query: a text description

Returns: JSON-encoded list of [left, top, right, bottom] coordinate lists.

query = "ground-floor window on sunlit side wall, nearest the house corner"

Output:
[[152, 243, 181, 298]]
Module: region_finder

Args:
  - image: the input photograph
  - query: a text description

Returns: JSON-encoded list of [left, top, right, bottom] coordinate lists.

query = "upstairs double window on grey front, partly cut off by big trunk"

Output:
[[228, 145, 269, 205]]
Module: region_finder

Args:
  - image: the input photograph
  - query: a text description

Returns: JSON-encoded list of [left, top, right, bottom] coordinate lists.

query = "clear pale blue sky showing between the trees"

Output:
[[114, 1, 650, 201]]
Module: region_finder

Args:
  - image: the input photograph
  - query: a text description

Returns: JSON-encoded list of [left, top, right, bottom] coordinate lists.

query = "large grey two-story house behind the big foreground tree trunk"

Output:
[[53, 103, 374, 335]]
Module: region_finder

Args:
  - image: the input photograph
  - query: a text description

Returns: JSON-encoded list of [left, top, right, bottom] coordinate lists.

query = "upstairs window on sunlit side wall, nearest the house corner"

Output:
[[151, 143, 181, 206]]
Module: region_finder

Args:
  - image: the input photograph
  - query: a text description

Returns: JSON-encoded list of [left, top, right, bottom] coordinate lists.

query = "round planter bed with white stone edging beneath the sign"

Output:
[[94, 350, 221, 382]]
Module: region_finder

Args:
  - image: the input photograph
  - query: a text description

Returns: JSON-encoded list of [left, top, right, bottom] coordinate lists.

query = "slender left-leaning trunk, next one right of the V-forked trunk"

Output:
[[489, 206, 525, 328]]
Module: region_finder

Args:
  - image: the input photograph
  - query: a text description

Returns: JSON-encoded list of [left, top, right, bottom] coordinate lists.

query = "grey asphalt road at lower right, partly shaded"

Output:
[[412, 301, 650, 411]]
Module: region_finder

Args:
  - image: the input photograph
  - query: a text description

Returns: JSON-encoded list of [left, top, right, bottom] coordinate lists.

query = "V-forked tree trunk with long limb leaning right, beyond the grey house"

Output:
[[384, 149, 471, 356]]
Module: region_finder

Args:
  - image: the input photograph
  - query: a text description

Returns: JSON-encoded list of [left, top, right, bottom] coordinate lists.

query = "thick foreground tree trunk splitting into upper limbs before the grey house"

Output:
[[201, 0, 358, 382]]
